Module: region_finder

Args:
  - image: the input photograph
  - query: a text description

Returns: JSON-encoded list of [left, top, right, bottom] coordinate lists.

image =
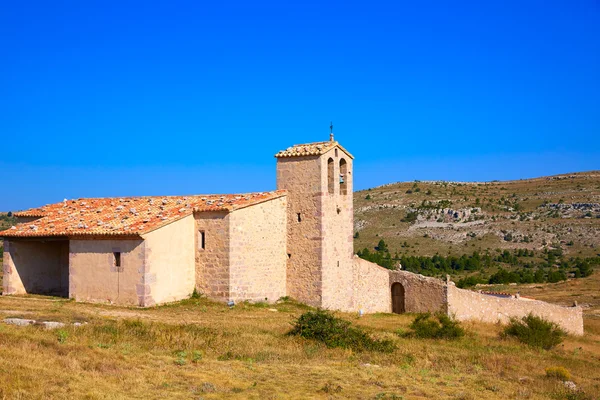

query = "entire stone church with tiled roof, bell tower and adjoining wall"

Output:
[[0, 135, 583, 334]]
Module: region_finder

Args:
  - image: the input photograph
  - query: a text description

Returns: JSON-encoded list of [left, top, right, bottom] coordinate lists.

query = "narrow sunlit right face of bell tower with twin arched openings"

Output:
[[319, 147, 354, 311]]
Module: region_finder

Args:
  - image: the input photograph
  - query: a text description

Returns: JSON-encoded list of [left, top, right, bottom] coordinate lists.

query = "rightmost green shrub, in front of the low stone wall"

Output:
[[502, 314, 566, 350]]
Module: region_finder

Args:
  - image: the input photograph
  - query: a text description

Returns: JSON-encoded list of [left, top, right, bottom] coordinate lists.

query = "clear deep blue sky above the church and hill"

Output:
[[0, 0, 600, 211]]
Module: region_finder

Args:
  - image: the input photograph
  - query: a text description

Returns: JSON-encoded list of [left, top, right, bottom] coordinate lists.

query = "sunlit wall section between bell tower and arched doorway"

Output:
[[352, 256, 392, 313]]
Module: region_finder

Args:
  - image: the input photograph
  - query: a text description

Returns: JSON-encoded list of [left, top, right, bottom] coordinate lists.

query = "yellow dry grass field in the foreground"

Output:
[[0, 296, 600, 399]]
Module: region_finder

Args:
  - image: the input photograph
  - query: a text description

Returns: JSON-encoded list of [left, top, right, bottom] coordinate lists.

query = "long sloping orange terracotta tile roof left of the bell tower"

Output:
[[0, 190, 286, 237]]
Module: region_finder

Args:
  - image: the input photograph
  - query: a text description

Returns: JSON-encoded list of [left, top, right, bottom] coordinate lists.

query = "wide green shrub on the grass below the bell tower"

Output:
[[288, 309, 396, 353]]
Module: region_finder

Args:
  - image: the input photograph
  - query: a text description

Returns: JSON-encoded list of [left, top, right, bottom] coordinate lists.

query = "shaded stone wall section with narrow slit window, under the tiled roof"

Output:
[[194, 211, 230, 300]]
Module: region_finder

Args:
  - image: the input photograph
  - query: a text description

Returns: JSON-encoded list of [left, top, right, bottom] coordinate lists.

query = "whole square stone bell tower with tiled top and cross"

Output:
[[275, 133, 354, 310]]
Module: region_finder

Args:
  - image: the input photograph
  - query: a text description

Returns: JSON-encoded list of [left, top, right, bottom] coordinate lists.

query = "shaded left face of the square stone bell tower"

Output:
[[277, 156, 326, 306]]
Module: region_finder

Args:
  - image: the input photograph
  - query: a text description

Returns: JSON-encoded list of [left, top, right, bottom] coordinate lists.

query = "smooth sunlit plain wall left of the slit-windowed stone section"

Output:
[[143, 215, 196, 306]]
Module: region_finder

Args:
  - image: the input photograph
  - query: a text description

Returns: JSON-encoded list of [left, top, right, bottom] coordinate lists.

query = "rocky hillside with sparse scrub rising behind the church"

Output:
[[354, 171, 600, 257]]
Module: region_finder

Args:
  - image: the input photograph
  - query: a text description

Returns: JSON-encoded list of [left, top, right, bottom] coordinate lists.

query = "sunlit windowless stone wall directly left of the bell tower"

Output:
[[229, 196, 287, 302]]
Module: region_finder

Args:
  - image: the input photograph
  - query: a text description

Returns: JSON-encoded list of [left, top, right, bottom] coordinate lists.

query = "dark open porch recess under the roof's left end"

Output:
[[2, 240, 69, 297]]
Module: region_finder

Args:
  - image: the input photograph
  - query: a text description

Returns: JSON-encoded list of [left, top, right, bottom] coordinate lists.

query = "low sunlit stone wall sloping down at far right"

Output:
[[447, 283, 583, 335]]
